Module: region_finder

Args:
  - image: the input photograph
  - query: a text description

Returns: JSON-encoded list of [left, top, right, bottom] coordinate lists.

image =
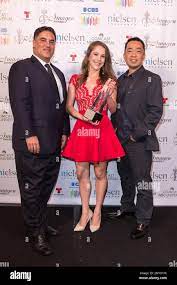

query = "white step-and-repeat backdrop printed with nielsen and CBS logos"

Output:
[[0, 0, 177, 205]]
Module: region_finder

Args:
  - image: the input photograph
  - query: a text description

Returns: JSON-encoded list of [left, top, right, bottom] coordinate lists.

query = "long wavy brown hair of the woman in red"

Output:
[[78, 41, 116, 85]]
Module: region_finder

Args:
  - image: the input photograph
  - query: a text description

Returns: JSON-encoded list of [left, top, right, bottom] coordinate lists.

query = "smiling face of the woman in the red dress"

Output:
[[88, 45, 105, 71]]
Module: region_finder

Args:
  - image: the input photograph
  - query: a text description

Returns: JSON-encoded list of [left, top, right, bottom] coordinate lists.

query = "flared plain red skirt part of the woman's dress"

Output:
[[61, 114, 125, 163]]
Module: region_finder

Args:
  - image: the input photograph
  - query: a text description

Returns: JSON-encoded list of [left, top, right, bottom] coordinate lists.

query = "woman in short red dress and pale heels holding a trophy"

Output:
[[62, 41, 124, 232]]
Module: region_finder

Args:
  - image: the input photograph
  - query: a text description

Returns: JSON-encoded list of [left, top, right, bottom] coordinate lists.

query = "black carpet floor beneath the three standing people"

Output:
[[0, 206, 177, 278]]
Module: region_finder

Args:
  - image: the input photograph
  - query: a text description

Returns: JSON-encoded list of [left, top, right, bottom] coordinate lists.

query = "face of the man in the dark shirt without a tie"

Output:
[[124, 41, 145, 73]]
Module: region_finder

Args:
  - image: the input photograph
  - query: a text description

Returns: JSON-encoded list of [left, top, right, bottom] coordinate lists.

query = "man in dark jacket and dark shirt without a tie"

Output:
[[112, 37, 163, 239]]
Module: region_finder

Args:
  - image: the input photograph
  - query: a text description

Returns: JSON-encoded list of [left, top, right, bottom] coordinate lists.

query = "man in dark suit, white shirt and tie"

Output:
[[9, 26, 70, 255]]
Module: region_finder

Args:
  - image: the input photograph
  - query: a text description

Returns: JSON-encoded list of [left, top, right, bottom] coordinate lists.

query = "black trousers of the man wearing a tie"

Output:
[[15, 152, 60, 235]]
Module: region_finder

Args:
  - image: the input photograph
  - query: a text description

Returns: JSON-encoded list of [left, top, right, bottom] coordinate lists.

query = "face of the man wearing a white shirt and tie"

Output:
[[33, 31, 55, 62]]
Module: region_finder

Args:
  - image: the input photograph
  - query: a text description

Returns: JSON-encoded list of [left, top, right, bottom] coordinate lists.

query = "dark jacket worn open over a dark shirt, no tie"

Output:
[[112, 66, 163, 151]]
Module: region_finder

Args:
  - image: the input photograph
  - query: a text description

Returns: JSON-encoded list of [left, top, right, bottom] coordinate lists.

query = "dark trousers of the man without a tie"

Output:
[[117, 141, 153, 225]]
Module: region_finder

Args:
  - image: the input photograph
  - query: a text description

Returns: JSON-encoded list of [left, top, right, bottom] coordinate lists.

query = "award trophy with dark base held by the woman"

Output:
[[84, 90, 109, 123]]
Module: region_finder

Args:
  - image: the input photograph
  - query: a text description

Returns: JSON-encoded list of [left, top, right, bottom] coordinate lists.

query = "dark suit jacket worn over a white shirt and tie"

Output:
[[9, 56, 70, 154]]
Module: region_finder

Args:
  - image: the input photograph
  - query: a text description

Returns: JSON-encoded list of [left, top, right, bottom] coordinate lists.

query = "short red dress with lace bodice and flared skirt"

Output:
[[62, 74, 125, 163]]
